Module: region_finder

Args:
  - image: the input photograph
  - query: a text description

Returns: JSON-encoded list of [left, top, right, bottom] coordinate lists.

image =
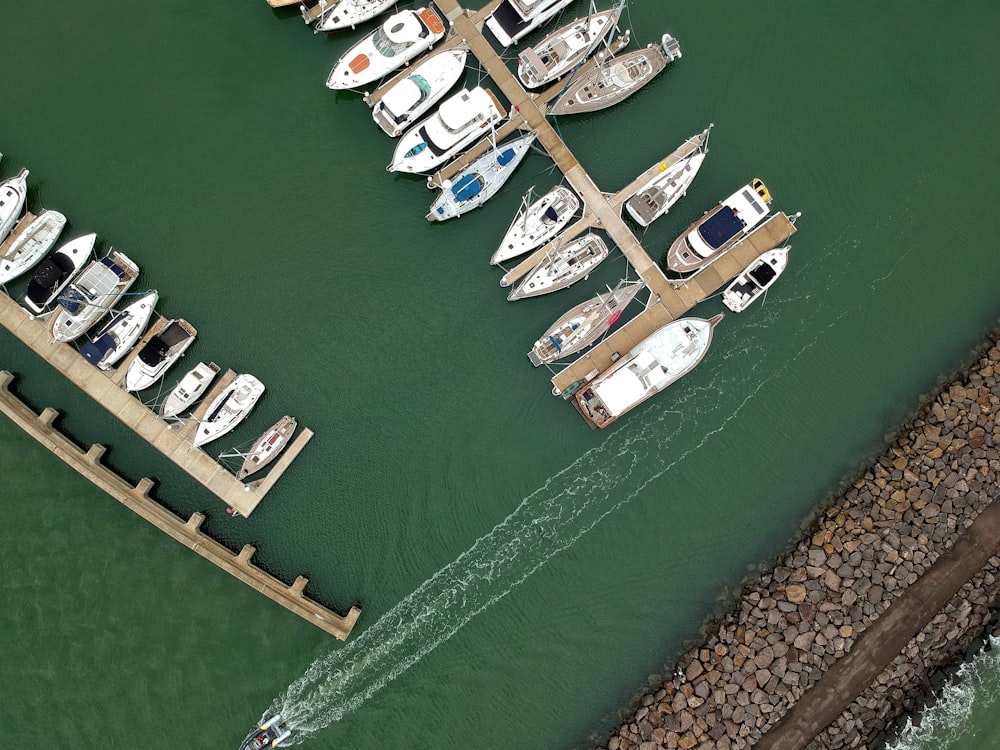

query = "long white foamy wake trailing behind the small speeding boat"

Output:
[[266, 235, 868, 744]]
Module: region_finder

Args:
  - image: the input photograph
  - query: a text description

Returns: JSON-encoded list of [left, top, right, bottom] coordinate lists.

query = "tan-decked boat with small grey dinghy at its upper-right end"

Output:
[[547, 34, 681, 115]]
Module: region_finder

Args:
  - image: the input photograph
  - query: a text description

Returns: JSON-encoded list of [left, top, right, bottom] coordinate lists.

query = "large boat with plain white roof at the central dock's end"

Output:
[[576, 314, 722, 428]]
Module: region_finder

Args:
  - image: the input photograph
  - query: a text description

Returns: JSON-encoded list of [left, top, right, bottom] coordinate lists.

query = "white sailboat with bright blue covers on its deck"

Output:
[[427, 132, 537, 221]]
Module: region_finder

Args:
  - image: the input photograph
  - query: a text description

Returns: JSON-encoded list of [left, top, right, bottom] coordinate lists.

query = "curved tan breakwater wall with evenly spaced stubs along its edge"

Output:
[[0, 370, 361, 641]]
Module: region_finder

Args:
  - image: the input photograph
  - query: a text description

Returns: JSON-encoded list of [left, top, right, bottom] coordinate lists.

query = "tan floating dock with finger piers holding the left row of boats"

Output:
[[0, 288, 313, 516]]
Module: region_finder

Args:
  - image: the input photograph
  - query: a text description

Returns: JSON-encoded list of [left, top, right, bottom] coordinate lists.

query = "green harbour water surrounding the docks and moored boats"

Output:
[[0, 0, 1000, 750]]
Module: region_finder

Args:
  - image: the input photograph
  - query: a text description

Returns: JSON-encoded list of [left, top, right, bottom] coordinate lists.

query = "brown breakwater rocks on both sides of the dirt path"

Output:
[[603, 336, 1000, 750]]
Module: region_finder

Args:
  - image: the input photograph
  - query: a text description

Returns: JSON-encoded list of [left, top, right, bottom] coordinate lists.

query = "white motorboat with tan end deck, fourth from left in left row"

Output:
[[49, 250, 139, 344]]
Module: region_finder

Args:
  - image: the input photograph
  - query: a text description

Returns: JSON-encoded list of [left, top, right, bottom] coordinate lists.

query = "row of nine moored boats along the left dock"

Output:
[[0, 157, 297, 479]]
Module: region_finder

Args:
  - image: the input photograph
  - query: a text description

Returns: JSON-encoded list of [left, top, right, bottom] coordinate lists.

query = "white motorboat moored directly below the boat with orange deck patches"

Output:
[[372, 46, 469, 138]]
